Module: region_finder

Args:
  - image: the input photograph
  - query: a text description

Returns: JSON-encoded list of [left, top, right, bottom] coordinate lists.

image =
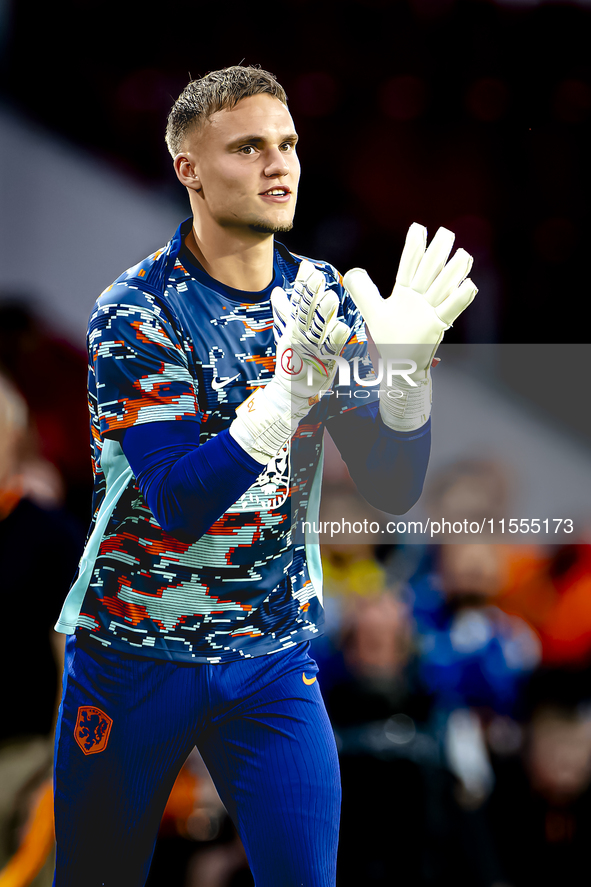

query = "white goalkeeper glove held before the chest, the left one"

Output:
[[230, 260, 351, 465]]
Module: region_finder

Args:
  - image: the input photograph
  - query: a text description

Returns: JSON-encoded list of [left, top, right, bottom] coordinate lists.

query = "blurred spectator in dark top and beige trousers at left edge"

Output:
[[0, 376, 83, 877]]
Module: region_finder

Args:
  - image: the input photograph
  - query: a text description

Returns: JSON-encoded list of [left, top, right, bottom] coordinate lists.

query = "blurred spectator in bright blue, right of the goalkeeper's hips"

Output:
[[412, 544, 540, 848]]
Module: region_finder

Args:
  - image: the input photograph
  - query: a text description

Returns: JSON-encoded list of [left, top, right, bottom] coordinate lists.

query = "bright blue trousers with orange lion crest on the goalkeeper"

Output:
[[53, 636, 341, 887]]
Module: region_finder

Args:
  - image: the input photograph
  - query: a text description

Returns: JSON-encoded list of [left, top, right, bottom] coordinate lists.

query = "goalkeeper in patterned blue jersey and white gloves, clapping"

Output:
[[49, 66, 475, 887]]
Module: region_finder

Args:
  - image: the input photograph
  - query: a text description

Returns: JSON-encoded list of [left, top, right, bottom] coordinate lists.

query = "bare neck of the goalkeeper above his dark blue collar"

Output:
[[185, 227, 273, 292]]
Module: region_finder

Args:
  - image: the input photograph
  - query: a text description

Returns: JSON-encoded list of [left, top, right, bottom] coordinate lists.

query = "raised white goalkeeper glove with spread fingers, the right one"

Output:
[[344, 222, 478, 431]]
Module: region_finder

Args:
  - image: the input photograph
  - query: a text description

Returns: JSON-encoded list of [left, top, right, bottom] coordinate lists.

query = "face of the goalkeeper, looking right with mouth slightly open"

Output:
[[185, 94, 300, 234]]
